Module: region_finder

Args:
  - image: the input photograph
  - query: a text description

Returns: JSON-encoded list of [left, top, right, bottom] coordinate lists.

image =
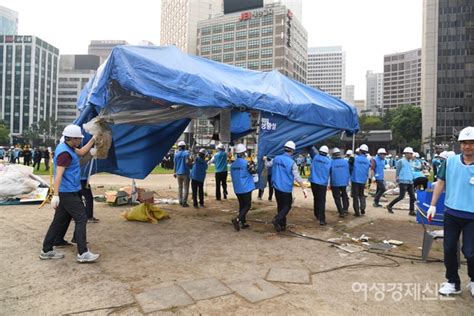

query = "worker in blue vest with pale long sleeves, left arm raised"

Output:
[[263, 140, 307, 232]]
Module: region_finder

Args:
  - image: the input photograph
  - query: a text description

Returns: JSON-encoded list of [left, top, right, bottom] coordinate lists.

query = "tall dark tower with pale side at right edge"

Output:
[[421, 0, 474, 149]]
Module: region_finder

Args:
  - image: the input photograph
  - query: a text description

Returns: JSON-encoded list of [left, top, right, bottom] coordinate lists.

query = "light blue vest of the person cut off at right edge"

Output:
[[444, 155, 474, 213]]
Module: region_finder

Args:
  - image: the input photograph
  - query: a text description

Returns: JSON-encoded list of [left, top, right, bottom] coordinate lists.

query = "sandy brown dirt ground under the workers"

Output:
[[0, 175, 474, 315]]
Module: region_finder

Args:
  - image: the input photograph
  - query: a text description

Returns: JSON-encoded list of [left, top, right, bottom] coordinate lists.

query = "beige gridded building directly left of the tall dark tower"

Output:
[[382, 49, 421, 113]]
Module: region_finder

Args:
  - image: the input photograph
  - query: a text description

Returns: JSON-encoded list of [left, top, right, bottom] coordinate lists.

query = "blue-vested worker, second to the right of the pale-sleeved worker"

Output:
[[329, 148, 351, 218]]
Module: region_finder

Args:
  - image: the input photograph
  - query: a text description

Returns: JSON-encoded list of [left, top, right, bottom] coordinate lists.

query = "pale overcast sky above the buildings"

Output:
[[0, 0, 422, 99]]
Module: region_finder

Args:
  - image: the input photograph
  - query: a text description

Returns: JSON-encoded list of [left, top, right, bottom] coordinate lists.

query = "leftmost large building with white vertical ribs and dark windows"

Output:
[[0, 35, 59, 138]]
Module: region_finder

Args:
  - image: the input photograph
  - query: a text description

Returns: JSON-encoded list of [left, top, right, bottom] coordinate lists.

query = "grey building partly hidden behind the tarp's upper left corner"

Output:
[[57, 55, 100, 130]]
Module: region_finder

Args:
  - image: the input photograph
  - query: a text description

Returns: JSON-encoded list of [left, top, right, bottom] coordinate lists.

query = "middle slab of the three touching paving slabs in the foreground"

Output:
[[178, 278, 233, 301]]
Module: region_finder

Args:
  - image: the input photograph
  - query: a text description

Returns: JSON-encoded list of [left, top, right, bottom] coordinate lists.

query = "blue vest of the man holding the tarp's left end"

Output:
[[54, 143, 81, 192]]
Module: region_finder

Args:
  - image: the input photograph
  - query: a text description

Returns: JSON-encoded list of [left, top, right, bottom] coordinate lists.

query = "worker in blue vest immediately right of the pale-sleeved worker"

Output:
[[308, 145, 331, 226]]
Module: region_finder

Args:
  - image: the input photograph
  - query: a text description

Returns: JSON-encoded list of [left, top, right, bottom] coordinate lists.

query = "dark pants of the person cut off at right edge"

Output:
[[443, 213, 474, 289]]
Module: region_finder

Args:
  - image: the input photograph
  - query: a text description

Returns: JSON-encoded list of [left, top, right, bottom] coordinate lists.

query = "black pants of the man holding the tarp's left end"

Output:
[[43, 192, 87, 255]]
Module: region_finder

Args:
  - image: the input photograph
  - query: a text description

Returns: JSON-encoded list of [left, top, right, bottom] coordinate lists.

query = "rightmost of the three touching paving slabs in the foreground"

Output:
[[227, 279, 286, 303]]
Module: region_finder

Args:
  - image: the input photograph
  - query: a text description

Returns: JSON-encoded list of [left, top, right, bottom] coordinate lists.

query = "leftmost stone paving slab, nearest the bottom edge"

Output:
[[135, 284, 194, 314]]
